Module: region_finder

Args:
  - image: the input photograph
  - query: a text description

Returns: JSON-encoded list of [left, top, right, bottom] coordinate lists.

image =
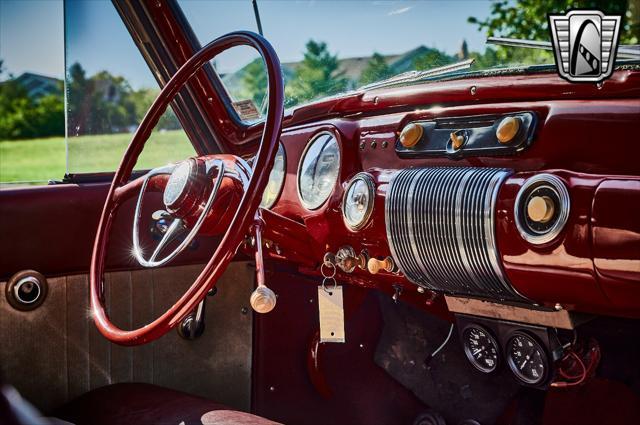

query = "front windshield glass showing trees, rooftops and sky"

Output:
[[179, 0, 638, 115]]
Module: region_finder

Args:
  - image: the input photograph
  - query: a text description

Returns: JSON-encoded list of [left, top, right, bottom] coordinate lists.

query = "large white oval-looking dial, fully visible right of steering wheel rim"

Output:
[[298, 132, 340, 210]]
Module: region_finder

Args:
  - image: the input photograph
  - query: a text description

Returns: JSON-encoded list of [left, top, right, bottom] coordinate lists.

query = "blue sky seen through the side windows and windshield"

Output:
[[0, 0, 490, 88]]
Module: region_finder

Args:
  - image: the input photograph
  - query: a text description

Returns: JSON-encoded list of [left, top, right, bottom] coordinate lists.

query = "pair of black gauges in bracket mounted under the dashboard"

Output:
[[456, 315, 562, 387]]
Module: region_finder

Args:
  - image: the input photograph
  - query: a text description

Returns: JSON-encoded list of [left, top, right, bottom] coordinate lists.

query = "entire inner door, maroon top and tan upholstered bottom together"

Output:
[[0, 183, 255, 412]]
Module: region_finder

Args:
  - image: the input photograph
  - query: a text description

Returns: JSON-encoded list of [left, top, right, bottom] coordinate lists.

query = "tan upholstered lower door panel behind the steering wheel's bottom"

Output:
[[0, 262, 255, 412]]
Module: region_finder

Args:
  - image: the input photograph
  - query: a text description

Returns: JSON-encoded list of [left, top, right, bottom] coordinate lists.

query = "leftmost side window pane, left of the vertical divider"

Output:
[[0, 0, 66, 187]]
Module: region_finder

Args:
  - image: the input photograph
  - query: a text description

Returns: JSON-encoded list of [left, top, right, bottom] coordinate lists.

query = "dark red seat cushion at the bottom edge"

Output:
[[54, 384, 275, 425]]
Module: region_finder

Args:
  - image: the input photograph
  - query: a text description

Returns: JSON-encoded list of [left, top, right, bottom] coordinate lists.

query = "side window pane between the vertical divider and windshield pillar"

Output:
[[65, 0, 194, 174]]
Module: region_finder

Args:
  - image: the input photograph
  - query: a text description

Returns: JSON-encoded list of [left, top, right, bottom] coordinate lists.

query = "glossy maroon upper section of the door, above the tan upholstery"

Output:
[[0, 183, 217, 279]]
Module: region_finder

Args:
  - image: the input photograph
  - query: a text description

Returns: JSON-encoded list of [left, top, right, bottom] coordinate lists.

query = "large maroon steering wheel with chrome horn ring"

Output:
[[90, 31, 284, 345]]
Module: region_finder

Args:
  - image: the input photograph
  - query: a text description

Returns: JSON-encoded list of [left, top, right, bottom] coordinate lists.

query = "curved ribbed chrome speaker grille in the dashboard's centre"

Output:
[[385, 167, 522, 300]]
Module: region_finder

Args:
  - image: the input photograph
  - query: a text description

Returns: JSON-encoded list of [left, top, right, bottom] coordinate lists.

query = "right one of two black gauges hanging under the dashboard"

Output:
[[506, 332, 547, 385]]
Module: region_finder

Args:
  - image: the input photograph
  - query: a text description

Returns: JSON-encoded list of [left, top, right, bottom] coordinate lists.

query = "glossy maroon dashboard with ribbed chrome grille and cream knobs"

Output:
[[256, 70, 640, 317]]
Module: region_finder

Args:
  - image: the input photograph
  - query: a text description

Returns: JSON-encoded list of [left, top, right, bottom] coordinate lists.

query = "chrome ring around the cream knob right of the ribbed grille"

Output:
[[513, 173, 571, 245]]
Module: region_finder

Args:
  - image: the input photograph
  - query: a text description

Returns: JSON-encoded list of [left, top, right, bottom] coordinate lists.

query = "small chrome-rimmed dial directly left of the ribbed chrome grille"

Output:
[[342, 173, 375, 230]]
